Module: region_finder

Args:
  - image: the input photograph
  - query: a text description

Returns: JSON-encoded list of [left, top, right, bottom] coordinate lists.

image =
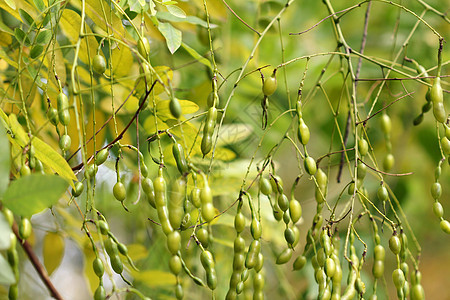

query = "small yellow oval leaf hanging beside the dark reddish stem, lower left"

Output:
[[42, 232, 64, 275]]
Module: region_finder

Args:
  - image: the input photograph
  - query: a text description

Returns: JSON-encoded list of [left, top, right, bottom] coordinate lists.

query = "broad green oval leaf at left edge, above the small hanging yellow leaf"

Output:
[[3, 174, 68, 217]]
